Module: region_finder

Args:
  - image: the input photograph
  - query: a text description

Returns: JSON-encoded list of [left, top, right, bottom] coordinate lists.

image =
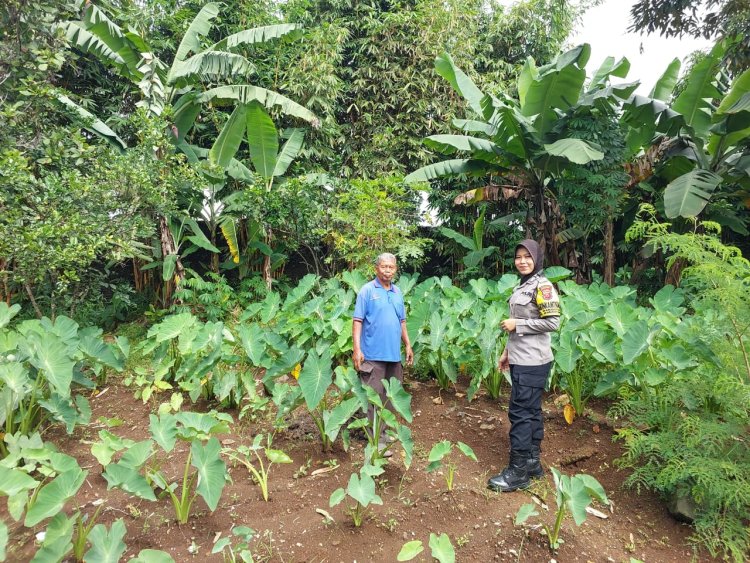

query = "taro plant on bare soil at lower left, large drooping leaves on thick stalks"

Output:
[[102, 411, 232, 524]]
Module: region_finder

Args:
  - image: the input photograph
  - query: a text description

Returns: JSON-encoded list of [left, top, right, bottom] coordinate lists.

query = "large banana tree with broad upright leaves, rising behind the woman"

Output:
[[406, 44, 637, 263]]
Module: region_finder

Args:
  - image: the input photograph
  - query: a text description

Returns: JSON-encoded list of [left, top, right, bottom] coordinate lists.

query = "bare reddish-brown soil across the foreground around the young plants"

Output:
[[5, 381, 711, 563]]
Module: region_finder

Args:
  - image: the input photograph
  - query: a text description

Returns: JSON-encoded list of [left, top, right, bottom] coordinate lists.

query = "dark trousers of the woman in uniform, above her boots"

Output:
[[508, 362, 552, 451]]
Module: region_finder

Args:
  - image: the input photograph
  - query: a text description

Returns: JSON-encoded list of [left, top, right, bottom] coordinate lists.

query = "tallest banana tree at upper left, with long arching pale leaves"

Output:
[[58, 1, 317, 298]]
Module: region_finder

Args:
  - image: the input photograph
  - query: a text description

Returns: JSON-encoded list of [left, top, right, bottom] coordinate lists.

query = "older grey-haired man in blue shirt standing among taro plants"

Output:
[[352, 253, 414, 453]]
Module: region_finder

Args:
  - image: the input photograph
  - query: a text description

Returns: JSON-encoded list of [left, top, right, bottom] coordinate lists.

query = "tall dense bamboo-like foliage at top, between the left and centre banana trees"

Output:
[[280, 0, 577, 176]]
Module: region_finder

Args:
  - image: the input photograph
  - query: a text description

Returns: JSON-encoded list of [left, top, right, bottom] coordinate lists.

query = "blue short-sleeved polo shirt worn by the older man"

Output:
[[354, 278, 406, 362]]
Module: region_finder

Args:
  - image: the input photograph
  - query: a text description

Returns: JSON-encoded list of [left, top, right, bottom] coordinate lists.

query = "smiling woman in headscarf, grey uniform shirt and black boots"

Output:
[[487, 239, 560, 492]]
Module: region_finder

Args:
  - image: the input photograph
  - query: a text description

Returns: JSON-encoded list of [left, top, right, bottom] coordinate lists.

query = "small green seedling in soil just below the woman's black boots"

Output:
[[515, 467, 609, 551]]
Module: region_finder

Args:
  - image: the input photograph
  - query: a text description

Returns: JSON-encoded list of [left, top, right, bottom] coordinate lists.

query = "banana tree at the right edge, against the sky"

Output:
[[623, 43, 750, 231]]
